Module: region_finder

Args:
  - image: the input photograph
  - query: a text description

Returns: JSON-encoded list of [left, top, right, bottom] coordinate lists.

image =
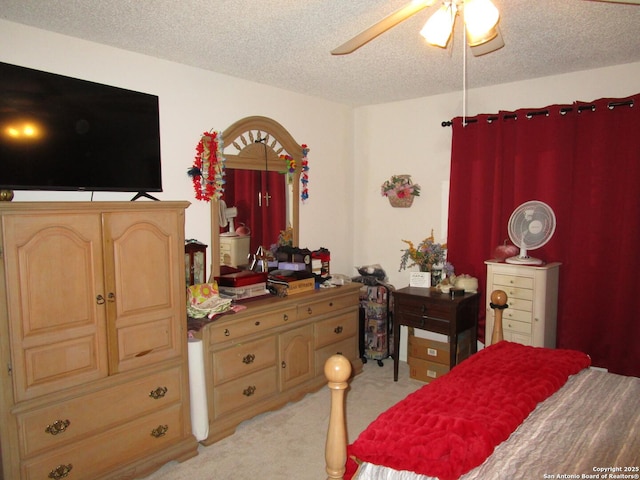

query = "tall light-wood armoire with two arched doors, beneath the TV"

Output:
[[0, 202, 197, 480]]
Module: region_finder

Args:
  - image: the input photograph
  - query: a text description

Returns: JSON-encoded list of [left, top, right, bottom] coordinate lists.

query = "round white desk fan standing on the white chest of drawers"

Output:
[[505, 200, 556, 265]]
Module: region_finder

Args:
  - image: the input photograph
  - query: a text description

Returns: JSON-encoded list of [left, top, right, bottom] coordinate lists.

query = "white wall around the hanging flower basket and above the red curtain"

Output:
[[354, 63, 640, 288]]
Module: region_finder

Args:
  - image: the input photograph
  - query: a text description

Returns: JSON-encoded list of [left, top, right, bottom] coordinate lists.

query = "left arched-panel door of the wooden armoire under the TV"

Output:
[[3, 212, 108, 401]]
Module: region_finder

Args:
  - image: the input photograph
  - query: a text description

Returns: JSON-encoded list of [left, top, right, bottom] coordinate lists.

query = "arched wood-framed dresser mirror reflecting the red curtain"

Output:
[[211, 116, 303, 276]]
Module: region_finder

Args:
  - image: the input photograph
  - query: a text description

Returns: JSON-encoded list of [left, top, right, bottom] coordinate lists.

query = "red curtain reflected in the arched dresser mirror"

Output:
[[222, 169, 287, 252]]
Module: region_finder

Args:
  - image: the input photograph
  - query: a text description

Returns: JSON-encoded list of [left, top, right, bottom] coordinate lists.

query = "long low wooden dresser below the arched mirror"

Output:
[[196, 284, 362, 445]]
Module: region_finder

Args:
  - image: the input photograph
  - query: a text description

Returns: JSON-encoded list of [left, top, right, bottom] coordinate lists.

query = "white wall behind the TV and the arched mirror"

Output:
[[0, 20, 353, 272]]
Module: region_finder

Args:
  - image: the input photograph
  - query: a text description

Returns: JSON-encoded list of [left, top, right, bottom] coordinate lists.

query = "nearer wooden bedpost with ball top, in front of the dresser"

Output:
[[324, 355, 351, 480]]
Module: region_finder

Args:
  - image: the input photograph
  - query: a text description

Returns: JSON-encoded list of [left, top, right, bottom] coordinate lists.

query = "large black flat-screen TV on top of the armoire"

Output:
[[0, 62, 162, 192]]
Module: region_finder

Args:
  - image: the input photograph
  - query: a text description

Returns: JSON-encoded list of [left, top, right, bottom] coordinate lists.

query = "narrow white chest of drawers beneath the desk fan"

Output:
[[485, 260, 560, 348]]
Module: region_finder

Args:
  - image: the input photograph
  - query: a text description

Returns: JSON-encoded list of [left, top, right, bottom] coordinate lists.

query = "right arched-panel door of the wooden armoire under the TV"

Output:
[[104, 211, 184, 373]]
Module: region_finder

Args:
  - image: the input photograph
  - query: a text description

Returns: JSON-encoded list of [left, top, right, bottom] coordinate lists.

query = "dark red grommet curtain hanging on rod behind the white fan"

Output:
[[447, 95, 640, 376]]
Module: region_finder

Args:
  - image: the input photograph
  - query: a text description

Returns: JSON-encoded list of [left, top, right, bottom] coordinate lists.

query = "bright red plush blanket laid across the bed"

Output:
[[344, 341, 590, 480]]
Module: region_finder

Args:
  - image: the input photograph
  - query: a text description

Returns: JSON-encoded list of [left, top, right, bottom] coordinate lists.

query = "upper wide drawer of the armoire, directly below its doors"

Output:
[[16, 367, 182, 460]]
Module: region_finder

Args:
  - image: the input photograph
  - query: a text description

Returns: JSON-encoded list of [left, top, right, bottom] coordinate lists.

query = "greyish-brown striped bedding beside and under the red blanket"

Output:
[[354, 369, 640, 480]]
